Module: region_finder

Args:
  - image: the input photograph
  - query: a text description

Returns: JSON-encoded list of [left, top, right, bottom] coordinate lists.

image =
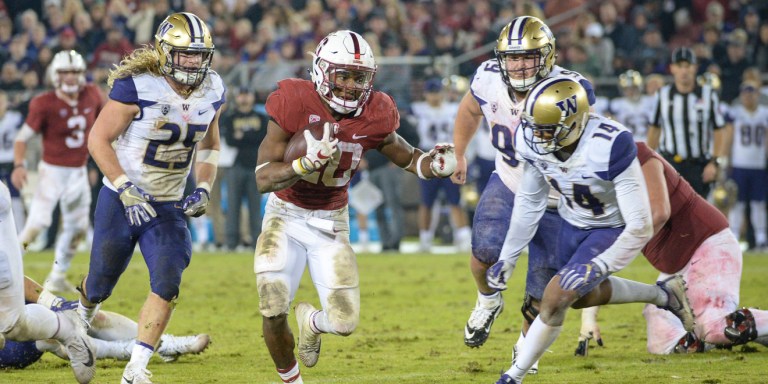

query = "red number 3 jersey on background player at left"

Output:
[[26, 84, 102, 167]]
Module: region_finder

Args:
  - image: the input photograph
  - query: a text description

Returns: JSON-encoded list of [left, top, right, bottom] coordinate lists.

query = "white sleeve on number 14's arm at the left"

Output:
[[499, 162, 549, 266]]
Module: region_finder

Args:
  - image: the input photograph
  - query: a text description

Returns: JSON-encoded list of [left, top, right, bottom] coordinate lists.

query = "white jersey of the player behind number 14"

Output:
[[469, 59, 595, 200]]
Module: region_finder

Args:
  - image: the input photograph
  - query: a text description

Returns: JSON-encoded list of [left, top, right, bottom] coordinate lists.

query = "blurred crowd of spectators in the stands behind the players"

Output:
[[0, 0, 768, 252]]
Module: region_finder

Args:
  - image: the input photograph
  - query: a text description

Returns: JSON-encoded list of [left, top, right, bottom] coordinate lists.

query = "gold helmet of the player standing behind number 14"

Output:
[[494, 16, 556, 92]]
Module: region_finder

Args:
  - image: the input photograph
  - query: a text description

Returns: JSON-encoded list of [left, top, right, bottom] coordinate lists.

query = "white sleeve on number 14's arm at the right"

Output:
[[592, 160, 653, 273]]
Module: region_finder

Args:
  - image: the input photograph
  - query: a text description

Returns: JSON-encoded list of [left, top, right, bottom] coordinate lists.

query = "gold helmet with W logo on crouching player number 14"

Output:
[[522, 76, 589, 154]]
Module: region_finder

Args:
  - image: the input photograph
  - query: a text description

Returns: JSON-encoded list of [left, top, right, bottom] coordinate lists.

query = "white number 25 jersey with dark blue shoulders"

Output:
[[104, 71, 226, 201]]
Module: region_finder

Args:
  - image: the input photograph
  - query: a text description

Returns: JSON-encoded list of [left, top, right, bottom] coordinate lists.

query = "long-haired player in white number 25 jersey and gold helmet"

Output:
[[73, 12, 226, 384]]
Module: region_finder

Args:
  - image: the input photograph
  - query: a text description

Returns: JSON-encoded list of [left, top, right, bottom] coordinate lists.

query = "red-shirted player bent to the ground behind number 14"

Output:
[[582, 143, 768, 354]]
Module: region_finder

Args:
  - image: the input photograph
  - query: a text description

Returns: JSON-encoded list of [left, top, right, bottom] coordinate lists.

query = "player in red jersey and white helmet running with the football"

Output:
[[254, 30, 456, 383]]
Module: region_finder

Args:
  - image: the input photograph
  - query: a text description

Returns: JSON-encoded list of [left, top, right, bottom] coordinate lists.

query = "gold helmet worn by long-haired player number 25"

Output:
[[155, 12, 215, 87]]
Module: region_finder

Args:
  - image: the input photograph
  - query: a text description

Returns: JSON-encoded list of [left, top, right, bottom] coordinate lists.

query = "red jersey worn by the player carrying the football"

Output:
[[266, 79, 400, 210]]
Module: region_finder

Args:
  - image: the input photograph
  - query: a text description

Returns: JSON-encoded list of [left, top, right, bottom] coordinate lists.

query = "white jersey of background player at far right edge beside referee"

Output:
[[726, 104, 768, 169]]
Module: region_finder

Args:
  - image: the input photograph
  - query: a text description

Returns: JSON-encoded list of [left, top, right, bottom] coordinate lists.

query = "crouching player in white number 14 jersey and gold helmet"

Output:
[[486, 76, 694, 384]]
